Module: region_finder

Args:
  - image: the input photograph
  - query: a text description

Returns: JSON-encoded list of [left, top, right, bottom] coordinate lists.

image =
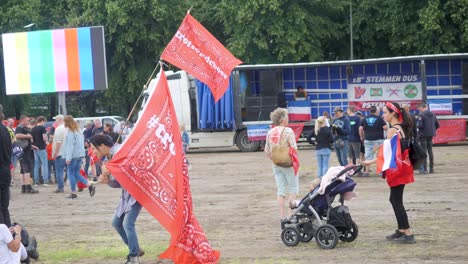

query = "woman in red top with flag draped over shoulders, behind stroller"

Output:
[[363, 102, 416, 244]]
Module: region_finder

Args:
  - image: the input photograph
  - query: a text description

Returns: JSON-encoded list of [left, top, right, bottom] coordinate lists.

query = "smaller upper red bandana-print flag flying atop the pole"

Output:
[[161, 14, 242, 102]]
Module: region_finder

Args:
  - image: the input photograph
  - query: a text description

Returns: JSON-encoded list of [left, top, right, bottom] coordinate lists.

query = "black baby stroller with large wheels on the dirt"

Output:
[[281, 165, 363, 249]]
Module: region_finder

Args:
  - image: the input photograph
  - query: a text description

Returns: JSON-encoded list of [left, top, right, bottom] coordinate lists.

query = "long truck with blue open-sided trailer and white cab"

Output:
[[143, 53, 468, 152]]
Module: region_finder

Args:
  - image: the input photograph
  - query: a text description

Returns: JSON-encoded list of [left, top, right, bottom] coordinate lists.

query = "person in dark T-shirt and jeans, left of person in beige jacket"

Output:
[[31, 116, 50, 186]]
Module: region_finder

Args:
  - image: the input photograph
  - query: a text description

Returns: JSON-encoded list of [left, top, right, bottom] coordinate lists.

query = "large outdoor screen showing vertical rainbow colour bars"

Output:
[[2, 26, 107, 95]]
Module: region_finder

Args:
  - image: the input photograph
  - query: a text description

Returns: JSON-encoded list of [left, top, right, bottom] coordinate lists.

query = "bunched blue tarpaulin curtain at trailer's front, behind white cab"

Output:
[[196, 78, 236, 130]]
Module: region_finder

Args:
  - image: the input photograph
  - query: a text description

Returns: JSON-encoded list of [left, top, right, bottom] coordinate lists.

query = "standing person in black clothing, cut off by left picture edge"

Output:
[[0, 105, 12, 226]]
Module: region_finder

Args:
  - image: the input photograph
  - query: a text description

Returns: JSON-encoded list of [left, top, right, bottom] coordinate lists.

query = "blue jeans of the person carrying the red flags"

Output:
[[112, 202, 141, 257]]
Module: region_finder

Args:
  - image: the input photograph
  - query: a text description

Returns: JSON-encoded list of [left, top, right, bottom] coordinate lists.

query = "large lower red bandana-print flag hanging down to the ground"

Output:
[[106, 71, 219, 263]]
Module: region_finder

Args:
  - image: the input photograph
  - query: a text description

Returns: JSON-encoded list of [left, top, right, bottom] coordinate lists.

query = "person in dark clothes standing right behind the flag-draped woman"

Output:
[[417, 103, 440, 174]]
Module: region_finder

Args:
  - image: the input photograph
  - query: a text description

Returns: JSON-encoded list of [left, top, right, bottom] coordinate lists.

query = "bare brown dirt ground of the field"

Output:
[[6, 144, 468, 264]]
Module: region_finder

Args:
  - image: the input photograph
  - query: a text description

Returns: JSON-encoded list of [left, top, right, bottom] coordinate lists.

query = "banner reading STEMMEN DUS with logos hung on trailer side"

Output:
[[348, 73, 423, 110]]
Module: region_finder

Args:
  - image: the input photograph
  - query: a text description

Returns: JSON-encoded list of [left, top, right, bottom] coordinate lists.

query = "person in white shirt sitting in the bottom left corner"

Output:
[[0, 224, 28, 264]]
